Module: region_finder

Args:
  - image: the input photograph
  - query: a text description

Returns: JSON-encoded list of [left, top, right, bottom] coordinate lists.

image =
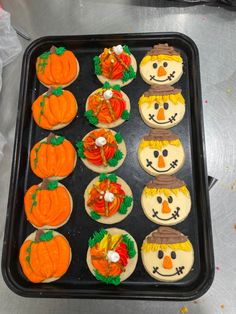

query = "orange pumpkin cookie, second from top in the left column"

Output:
[[32, 87, 78, 130]]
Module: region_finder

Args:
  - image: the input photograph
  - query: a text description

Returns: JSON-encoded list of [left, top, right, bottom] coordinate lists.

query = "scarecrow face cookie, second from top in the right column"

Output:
[[139, 85, 185, 129]]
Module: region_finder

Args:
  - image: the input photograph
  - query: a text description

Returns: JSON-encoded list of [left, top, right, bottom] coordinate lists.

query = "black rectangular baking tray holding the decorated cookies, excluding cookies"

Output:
[[2, 33, 214, 300]]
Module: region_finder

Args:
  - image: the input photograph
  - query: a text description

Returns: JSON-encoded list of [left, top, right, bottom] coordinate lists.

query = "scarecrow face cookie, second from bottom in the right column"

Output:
[[141, 174, 191, 225]]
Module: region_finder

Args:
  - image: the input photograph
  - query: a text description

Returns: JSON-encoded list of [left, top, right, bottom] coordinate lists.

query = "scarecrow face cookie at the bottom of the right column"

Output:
[[141, 227, 194, 281]]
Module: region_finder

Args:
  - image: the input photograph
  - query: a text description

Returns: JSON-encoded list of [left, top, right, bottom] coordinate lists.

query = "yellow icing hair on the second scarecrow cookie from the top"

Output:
[[138, 93, 185, 107]]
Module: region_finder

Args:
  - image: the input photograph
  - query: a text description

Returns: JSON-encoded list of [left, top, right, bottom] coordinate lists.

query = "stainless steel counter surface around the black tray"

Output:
[[0, 0, 236, 314]]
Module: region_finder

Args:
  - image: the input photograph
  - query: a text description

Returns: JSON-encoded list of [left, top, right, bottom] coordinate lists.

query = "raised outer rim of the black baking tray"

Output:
[[1, 32, 215, 301]]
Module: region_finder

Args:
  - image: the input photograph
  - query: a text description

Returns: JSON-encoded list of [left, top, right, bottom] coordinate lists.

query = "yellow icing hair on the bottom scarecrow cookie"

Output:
[[141, 240, 192, 252]]
